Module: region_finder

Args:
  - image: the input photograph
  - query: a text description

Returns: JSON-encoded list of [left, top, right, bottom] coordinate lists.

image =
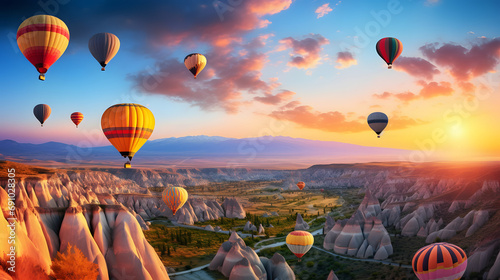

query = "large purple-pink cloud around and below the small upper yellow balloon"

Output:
[[131, 44, 276, 113]]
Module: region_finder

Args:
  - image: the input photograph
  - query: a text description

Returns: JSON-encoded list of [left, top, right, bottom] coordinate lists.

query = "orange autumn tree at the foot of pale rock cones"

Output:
[[51, 244, 99, 280]]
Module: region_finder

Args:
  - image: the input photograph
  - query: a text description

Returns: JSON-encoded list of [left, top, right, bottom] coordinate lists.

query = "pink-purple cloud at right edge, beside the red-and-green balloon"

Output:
[[420, 38, 500, 81]]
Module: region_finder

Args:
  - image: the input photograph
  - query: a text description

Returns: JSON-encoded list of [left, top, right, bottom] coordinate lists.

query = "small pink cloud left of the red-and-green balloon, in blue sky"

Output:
[[279, 33, 329, 69]]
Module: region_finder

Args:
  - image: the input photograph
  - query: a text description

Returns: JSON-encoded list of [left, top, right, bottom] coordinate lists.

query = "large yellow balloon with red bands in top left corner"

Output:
[[17, 15, 69, 81]]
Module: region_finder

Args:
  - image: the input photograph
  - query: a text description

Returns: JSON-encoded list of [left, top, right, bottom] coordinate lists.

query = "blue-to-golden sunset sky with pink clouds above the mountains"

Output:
[[0, 0, 500, 161]]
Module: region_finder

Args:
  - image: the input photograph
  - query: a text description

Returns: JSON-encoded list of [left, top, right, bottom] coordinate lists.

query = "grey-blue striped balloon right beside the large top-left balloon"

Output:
[[89, 33, 120, 71]]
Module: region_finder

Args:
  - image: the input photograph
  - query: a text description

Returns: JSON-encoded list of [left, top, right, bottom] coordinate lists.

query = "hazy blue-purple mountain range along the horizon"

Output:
[[0, 135, 410, 168]]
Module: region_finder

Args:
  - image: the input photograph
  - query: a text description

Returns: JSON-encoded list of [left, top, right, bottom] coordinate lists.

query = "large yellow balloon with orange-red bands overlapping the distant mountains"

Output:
[[101, 103, 155, 167]]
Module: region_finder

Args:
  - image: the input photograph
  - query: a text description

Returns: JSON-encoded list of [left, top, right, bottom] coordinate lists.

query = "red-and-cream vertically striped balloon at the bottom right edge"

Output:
[[412, 242, 467, 280]]
